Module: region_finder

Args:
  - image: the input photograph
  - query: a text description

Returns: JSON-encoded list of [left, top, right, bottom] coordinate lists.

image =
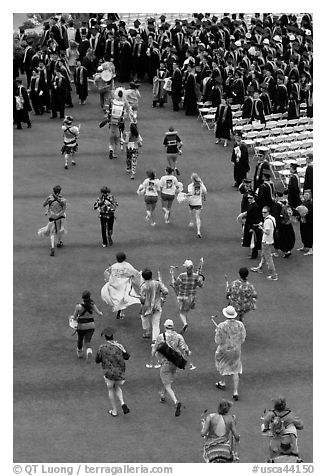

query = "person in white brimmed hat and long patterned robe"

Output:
[[215, 306, 246, 401]]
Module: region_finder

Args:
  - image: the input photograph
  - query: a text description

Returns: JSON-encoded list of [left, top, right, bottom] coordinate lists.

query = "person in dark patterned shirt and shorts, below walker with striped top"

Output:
[[95, 327, 130, 417]]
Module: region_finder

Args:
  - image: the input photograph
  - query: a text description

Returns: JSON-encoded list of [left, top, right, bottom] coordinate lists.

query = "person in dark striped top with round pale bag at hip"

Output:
[[74, 290, 103, 362]]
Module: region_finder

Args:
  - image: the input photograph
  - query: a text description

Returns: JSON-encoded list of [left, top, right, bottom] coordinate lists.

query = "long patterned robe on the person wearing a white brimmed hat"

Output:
[[215, 319, 246, 376]]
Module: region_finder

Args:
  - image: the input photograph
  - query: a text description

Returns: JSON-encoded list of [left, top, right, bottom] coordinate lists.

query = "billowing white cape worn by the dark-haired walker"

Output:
[[101, 261, 141, 312]]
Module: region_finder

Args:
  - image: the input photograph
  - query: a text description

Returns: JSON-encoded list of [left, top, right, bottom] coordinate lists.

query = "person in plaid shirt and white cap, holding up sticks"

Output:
[[174, 259, 203, 332]]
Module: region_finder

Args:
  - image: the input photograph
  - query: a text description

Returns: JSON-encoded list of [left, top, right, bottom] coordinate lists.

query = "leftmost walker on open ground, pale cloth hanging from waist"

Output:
[[37, 185, 67, 256]]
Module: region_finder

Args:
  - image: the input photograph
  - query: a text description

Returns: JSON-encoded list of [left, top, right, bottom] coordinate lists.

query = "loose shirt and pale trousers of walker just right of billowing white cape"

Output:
[[140, 279, 169, 342]]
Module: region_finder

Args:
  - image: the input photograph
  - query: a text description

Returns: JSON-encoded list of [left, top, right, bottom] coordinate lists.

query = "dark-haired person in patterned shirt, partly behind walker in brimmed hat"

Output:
[[226, 268, 257, 321]]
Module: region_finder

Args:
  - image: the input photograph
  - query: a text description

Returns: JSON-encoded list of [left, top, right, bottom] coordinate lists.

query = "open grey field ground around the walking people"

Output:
[[13, 79, 313, 463]]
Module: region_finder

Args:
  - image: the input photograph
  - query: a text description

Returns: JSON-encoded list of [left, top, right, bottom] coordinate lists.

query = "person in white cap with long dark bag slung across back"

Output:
[[152, 319, 191, 417]]
